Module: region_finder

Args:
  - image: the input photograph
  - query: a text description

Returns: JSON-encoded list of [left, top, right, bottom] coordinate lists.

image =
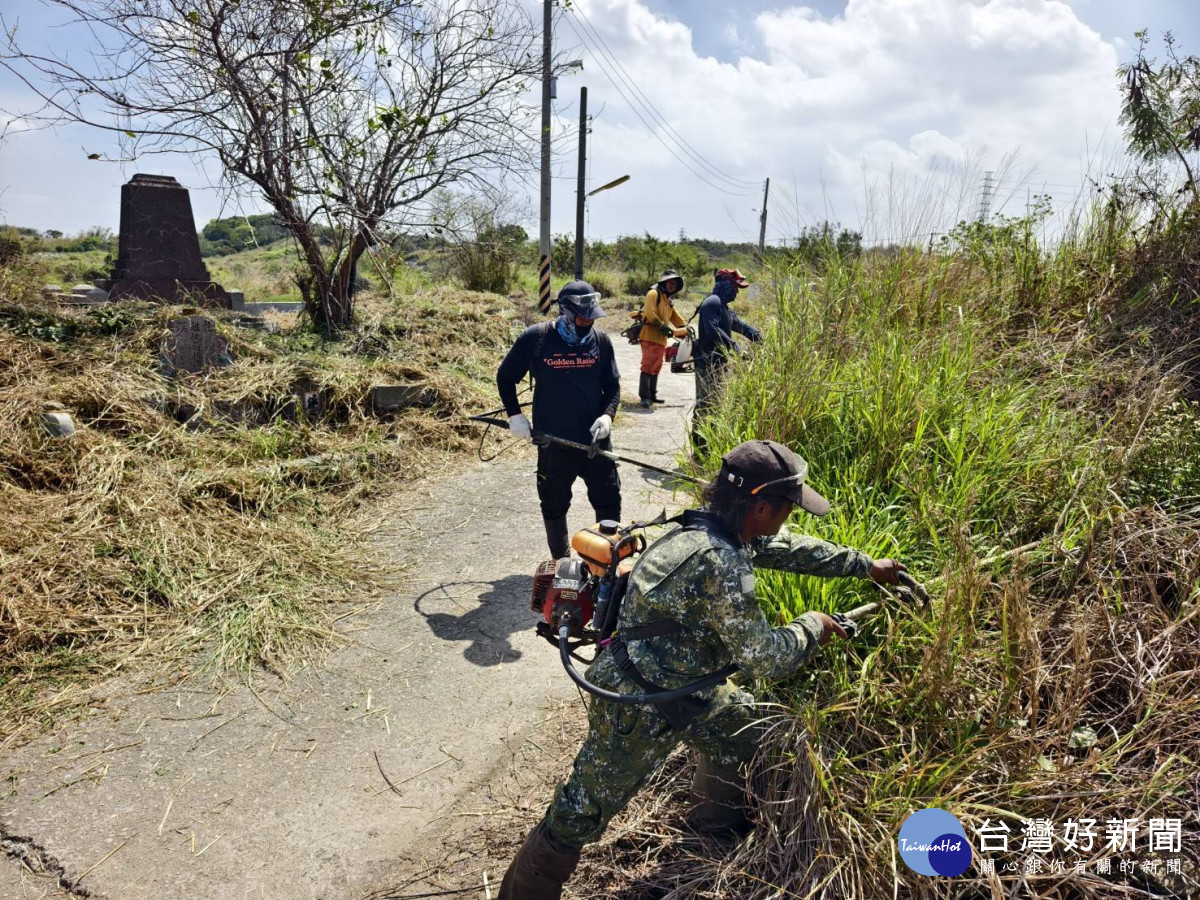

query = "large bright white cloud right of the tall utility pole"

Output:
[[554, 0, 1118, 244]]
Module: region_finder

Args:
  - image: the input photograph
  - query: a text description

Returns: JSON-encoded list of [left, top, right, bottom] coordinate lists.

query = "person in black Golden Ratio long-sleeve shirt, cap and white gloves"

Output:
[[496, 281, 620, 559]]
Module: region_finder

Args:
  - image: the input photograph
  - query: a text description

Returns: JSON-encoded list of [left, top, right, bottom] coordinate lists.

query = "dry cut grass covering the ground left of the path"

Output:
[[0, 264, 523, 748]]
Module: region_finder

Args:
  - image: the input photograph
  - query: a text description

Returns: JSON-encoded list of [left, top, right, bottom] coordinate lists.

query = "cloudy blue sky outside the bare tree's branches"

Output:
[[0, 0, 1200, 240]]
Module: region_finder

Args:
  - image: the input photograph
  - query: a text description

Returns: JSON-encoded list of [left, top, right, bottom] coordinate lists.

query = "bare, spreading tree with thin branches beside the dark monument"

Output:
[[0, 0, 538, 330]]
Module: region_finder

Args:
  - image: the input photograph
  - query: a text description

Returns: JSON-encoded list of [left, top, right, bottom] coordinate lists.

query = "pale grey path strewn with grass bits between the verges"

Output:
[[0, 338, 692, 900]]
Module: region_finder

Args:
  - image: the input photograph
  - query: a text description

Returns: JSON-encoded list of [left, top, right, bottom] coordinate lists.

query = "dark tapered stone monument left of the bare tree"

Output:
[[97, 174, 230, 310]]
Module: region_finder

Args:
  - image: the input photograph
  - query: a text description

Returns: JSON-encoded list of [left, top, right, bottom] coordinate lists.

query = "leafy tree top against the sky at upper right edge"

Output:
[[1120, 31, 1200, 203]]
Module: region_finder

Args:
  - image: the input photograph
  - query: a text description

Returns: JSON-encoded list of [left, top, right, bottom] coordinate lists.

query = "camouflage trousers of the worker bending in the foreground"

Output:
[[546, 654, 762, 848]]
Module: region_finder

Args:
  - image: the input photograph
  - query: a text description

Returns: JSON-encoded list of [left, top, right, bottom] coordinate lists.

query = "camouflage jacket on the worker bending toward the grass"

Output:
[[594, 511, 872, 690]]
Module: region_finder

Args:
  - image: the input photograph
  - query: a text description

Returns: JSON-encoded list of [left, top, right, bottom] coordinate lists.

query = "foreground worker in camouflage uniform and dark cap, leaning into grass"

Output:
[[500, 440, 905, 900]]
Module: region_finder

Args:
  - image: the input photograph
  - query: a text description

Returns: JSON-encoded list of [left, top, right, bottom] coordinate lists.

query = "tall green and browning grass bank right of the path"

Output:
[[685, 218, 1200, 898]]
